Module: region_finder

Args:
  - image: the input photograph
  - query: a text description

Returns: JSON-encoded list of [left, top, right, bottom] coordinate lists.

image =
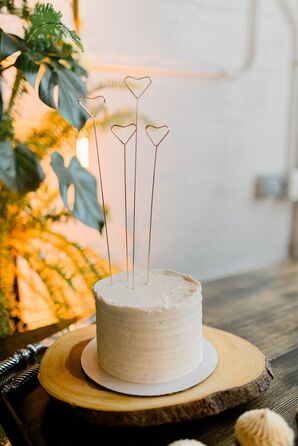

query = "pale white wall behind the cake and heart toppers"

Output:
[[7, 0, 291, 280]]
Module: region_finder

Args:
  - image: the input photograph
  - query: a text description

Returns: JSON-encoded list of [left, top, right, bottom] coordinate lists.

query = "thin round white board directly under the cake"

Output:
[[81, 338, 218, 396]]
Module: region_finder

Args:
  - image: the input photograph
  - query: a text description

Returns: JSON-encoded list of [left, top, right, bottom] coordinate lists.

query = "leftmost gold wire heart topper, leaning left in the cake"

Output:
[[78, 96, 113, 285]]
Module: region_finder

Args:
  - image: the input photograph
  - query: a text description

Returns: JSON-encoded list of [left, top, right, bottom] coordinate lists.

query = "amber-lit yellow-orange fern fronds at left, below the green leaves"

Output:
[[0, 179, 108, 336]]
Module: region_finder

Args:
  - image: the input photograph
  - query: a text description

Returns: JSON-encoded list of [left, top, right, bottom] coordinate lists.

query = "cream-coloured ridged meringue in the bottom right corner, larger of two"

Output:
[[235, 409, 294, 446]]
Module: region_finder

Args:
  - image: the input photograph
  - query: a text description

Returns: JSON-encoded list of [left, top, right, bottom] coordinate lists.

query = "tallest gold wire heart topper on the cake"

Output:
[[124, 76, 152, 288]]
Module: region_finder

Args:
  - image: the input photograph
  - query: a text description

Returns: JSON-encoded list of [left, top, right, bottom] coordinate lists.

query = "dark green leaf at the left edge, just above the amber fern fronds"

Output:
[[0, 141, 45, 194]]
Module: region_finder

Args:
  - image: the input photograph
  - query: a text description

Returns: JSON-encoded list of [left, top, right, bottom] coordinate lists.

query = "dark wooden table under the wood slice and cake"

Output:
[[0, 261, 298, 446]]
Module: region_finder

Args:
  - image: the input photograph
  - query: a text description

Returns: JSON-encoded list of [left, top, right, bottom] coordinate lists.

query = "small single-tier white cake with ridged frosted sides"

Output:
[[94, 270, 203, 384]]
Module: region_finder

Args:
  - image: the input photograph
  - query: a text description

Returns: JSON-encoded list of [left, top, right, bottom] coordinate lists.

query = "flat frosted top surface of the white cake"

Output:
[[94, 269, 201, 309]]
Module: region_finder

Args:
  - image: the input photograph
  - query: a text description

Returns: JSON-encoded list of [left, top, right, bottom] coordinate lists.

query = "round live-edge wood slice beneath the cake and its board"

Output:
[[39, 325, 273, 426]]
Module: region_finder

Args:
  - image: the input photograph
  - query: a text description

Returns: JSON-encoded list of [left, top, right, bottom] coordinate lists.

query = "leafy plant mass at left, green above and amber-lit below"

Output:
[[0, 0, 127, 335]]
